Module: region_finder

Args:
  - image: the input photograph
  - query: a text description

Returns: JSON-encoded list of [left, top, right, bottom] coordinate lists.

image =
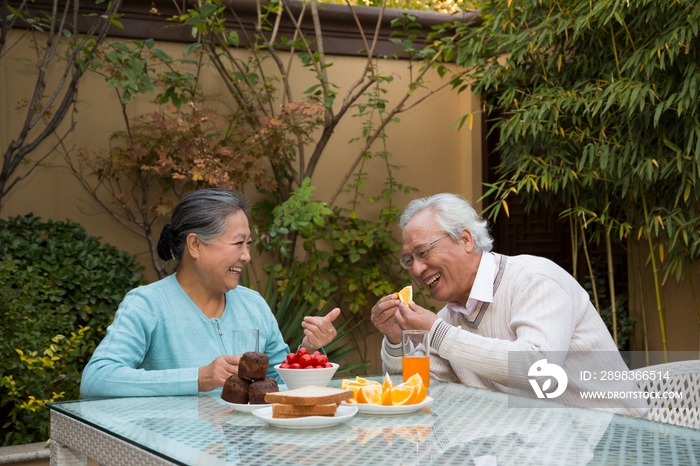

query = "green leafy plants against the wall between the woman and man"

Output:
[[253, 178, 416, 374]]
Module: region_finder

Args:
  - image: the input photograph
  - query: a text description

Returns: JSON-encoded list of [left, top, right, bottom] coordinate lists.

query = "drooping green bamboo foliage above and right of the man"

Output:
[[454, 0, 700, 278]]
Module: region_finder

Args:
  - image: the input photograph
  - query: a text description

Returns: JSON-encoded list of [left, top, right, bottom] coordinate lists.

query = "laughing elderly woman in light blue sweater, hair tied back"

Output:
[[80, 189, 340, 398]]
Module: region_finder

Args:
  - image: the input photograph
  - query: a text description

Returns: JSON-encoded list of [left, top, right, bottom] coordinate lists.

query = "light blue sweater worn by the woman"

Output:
[[80, 275, 289, 398]]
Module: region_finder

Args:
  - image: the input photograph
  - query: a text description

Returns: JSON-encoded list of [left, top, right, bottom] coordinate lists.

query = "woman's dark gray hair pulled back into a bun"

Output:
[[158, 188, 250, 262]]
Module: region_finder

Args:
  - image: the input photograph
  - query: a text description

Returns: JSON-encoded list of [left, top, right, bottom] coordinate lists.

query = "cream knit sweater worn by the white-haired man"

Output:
[[381, 254, 648, 417]]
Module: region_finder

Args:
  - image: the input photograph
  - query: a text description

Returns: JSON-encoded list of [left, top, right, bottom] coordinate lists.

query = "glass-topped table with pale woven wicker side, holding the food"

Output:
[[49, 380, 700, 466]]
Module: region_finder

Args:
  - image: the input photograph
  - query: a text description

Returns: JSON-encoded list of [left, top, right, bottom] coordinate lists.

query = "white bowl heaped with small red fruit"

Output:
[[275, 346, 340, 390]]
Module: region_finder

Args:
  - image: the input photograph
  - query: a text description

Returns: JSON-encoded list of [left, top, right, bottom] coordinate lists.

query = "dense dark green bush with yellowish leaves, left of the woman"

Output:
[[0, 215, 141, 445]]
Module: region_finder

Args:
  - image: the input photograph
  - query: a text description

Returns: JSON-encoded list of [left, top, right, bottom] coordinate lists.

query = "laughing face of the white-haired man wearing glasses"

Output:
[[402, 209, 481, 304]]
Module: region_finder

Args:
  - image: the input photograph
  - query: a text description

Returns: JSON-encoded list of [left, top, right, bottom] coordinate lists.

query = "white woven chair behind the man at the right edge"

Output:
[[634, 360, 700, 429]]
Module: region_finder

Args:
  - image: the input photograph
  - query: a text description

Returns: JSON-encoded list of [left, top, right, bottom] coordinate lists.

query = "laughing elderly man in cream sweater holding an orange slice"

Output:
[[372, 194, 648, 417]]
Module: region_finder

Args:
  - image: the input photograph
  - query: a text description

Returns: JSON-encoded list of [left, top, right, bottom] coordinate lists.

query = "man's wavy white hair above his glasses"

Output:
[[399, 193, 493, 252]]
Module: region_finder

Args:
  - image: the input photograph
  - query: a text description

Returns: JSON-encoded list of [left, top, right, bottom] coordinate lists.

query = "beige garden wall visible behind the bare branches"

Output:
[[0, 30, 481, 371]]
